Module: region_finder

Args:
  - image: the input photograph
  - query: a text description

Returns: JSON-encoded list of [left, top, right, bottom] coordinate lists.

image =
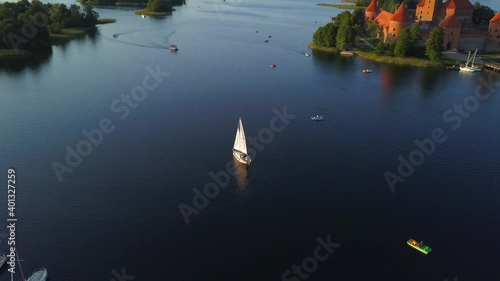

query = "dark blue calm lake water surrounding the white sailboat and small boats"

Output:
[[0, 0, 500, 281]]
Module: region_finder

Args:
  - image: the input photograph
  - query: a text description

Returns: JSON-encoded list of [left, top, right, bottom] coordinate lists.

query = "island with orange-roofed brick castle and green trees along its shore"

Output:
[[309, 0, 500, 67]]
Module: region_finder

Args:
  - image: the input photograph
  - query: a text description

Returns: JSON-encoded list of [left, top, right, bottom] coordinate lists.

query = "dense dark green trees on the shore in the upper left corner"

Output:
[[0, 0, 99, 52]]
